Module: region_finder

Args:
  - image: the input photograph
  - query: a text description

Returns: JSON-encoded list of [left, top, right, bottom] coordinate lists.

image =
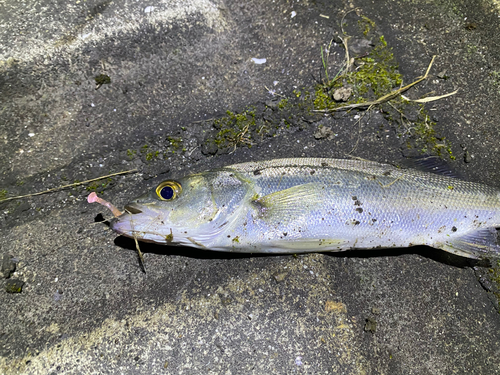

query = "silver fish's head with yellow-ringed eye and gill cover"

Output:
[[110, 171, 247, 248]]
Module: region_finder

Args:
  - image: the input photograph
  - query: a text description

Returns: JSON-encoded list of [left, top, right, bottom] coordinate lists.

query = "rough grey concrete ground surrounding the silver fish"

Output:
[[0, 0, 500, 374]]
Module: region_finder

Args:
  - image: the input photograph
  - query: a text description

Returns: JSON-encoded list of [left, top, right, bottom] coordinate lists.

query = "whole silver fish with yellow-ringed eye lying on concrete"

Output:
[[95, 158, 500, 259]]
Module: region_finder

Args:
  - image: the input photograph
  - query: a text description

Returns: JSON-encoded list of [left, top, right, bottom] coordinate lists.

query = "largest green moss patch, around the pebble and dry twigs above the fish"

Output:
[[313, 24, 455, 159]]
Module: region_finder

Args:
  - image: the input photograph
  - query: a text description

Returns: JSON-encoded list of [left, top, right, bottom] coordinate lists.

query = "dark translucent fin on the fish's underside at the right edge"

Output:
[[435, 228, 500, 259]]
